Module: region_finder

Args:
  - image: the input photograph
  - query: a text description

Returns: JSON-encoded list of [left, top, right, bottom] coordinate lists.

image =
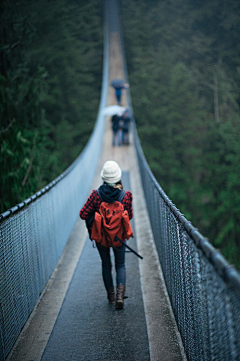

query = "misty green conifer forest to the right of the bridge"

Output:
[[121, 0, 240, 268]]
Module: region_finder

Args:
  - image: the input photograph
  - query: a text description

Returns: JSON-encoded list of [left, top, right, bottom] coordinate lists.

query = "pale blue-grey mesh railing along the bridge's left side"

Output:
[[0, 10, 108, 361]]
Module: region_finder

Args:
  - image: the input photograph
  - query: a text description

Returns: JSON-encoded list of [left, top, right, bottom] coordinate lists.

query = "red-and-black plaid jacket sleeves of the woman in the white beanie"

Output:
[[79, 190, 133, 219]]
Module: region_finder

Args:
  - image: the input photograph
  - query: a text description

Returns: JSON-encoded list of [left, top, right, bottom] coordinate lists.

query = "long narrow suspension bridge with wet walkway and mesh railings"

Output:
[[0, 0, 240, 361]]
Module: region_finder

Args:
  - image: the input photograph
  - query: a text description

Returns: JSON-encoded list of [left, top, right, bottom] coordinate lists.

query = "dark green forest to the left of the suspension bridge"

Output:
[[0, 0, 103, 213]]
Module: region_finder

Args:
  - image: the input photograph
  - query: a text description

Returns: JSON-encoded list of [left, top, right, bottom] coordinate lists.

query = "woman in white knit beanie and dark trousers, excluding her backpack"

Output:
[[80, 160, 133, 309]]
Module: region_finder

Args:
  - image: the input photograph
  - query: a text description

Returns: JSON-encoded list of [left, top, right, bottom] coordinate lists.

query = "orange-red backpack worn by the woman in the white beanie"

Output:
[[91, 201, 133, 247]]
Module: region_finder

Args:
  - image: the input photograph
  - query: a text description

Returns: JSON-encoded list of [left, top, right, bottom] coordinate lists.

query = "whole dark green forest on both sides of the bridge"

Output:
[[0, 0, 240, 269]]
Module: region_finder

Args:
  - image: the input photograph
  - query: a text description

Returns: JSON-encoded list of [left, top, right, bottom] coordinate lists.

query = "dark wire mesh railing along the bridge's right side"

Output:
[[131, 121, 240, 361]]
